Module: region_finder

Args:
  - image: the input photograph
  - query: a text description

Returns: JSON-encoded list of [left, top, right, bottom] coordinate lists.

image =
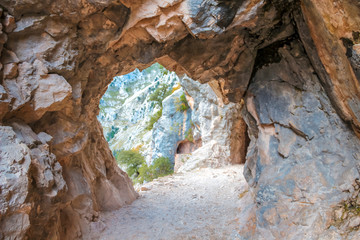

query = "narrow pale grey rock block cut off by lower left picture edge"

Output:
[[0, 127, 31, 239]]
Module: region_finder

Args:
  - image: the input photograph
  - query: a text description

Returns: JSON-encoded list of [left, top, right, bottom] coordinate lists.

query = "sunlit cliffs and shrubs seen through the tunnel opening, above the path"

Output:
[[98, 63, 246, 184]]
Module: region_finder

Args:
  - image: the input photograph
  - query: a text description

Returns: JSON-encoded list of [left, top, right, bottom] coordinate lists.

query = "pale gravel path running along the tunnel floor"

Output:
[[92, 165, 252, 240]]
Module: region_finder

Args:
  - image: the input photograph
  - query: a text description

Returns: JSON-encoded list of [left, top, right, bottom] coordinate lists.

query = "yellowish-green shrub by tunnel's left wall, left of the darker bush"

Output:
[[114, 150, 146, 179]]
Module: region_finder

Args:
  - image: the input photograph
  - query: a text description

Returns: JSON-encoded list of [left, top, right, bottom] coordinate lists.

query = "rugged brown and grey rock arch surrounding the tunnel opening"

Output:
[[0, 0, 360, 239]]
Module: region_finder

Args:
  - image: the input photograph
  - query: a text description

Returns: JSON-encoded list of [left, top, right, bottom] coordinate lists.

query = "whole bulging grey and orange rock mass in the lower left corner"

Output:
[[0, 121, 67, 239]]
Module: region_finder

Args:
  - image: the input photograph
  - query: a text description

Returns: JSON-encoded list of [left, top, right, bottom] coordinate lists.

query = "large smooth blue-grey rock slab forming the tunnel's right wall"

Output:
[[240, 41, 359, 239]]
